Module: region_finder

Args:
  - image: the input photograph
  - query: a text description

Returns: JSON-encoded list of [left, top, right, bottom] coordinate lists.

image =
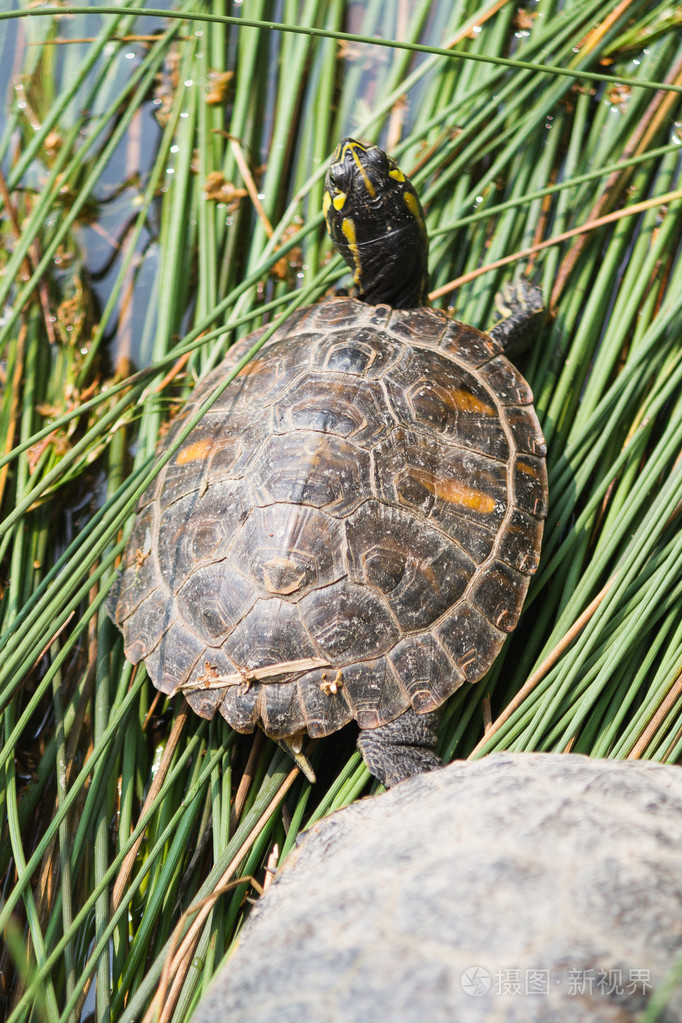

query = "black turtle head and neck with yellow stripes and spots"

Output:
[[324, 138, 428, 309]]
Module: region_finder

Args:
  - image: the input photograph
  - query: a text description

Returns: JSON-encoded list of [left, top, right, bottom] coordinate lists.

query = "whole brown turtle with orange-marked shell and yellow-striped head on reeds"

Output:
[[108, 138, 547, 787]]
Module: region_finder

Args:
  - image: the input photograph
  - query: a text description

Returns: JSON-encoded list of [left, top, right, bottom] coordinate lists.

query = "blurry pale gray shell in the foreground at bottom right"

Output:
[[192, 754, 682, 1023]]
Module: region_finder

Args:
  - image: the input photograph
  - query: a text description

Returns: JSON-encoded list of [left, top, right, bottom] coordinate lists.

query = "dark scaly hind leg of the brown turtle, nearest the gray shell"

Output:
[[358, 707, 443, 789]]
